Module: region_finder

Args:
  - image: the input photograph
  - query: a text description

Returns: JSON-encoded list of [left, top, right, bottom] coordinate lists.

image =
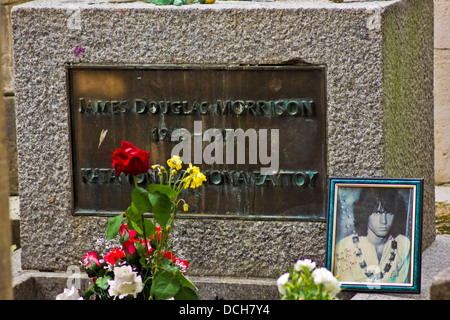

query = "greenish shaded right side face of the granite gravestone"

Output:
[[382, 1, 436, 246]]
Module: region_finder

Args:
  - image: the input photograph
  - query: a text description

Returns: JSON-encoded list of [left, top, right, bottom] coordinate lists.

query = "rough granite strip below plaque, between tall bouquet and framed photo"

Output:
[[173, 220, 326, 278]]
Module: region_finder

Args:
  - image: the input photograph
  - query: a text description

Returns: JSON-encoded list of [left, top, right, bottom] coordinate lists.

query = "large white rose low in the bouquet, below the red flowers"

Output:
[[108, 266, 144, 299]]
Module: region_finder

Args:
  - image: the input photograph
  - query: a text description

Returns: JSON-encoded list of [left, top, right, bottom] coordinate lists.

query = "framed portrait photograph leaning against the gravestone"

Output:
[[327, 178, 423, 293]]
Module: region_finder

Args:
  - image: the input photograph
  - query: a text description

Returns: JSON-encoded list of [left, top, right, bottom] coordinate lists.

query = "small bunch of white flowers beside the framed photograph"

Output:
[[277, 259, 341, 300]]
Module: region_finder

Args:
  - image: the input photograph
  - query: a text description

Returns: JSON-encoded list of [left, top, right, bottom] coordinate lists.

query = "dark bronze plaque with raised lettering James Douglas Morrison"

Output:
[[67, 65, 326, 220]]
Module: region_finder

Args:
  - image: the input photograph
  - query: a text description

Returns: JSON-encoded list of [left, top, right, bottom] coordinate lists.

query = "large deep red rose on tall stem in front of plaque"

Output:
[[111, 141, 150, 176]]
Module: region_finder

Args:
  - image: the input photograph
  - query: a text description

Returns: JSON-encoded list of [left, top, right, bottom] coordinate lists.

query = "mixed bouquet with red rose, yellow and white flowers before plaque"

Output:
[[63, 141, 206, 300]]
